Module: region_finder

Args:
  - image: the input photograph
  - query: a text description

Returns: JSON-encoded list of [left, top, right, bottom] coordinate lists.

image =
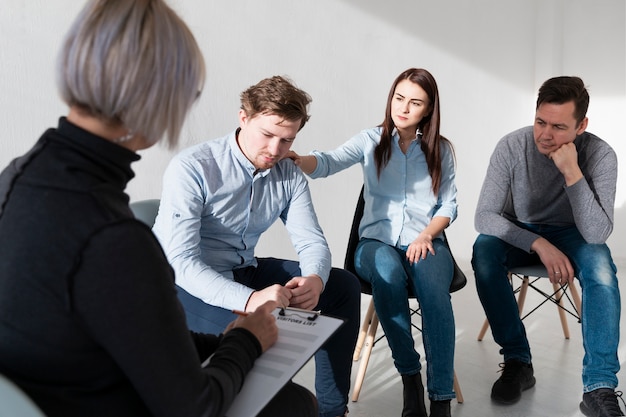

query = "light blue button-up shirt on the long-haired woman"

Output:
[[310, 127, 457, 246]]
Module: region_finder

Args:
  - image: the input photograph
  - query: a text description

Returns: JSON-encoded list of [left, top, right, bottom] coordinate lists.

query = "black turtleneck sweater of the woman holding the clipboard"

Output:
[[0, 118, 261, 417]]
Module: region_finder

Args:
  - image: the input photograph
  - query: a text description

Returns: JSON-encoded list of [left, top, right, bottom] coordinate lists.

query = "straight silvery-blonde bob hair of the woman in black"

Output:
[[57, 0, 205, 148]]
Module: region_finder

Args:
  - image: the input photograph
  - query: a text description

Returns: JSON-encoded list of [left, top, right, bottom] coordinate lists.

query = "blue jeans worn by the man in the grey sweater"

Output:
[[472, 224, 620, 392]]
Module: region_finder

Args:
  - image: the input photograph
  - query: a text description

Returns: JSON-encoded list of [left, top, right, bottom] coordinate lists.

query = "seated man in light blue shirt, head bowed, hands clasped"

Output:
[[153, 76, 360, 417]]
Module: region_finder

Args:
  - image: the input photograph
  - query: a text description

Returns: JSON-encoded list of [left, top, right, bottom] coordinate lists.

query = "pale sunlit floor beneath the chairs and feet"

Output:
[[294, 265, 626, 417]]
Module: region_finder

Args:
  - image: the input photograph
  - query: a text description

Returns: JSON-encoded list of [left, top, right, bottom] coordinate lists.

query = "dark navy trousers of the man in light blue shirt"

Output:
[[178, 258, 361, 417]]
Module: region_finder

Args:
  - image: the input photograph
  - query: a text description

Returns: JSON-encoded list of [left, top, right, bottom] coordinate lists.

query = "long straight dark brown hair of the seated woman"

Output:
[[374, 68, 452, 195]]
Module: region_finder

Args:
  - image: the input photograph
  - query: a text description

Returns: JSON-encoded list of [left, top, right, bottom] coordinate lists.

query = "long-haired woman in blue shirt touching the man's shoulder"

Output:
[[290, 68, 457, 417]]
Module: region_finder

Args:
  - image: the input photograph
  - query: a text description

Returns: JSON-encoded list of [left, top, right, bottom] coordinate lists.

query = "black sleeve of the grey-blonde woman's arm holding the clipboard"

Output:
[[72, 220, 260, 417]]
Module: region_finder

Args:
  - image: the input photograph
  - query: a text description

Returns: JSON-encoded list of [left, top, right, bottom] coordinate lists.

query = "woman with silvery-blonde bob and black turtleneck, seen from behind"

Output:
[[0, 0, 316, 417]]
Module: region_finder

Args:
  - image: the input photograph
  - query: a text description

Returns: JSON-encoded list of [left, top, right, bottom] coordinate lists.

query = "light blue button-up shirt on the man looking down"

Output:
[[153, 132, 331, 310]]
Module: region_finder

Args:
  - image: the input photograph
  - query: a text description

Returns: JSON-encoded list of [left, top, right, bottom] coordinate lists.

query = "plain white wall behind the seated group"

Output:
[[0, 0, 626, 266]]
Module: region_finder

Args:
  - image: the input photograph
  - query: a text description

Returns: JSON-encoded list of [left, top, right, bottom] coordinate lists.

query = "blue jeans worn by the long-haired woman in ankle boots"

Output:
[[354, 239, 456, 401]]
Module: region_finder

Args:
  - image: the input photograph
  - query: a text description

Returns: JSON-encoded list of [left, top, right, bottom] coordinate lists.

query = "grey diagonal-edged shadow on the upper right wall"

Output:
[[336, 0, 626, 97]]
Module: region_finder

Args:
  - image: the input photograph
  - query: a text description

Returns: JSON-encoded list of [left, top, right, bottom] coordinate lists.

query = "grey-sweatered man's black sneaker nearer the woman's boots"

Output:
[[491, 359, 535, 404]]
